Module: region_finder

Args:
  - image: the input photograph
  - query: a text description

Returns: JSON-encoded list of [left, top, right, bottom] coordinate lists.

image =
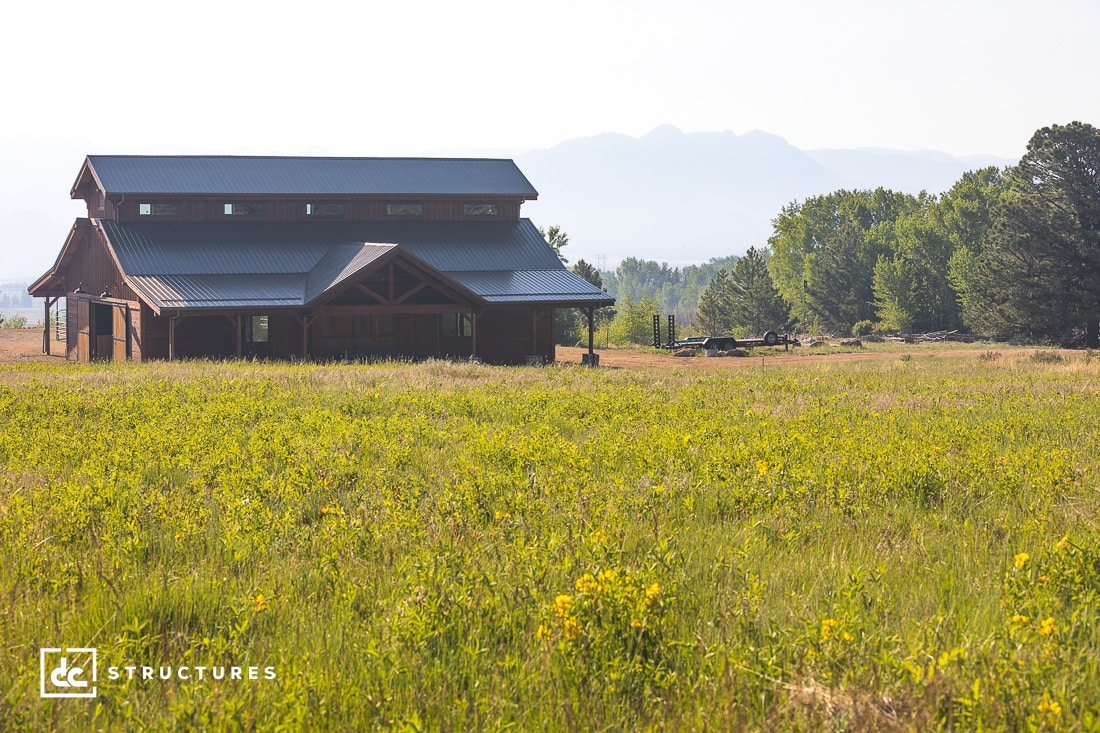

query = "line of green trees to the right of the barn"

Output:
[[558, 122, 1100, 347]]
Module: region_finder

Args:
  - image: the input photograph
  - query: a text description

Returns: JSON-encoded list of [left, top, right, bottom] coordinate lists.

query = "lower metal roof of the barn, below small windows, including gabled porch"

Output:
[[98, 219, 614, 309]]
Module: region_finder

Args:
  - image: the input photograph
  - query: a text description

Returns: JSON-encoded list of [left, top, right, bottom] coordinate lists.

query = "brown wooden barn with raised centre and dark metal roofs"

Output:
[[29, 155, 614, 363]]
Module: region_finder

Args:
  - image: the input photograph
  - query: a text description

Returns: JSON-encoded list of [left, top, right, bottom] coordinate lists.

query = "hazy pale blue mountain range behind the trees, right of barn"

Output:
[[514, 127, 1015, 269]]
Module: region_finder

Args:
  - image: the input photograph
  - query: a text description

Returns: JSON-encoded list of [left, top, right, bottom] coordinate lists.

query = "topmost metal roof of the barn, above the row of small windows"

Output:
[[87, 155, 538, 198]]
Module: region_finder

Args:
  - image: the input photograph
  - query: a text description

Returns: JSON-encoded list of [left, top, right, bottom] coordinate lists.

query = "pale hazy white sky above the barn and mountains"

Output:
[[0, 0, 1100, 278]]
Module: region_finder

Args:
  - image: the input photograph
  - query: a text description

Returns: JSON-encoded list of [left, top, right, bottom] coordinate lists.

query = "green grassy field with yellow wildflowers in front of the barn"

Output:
[[0, 347, 1100, 731]]
